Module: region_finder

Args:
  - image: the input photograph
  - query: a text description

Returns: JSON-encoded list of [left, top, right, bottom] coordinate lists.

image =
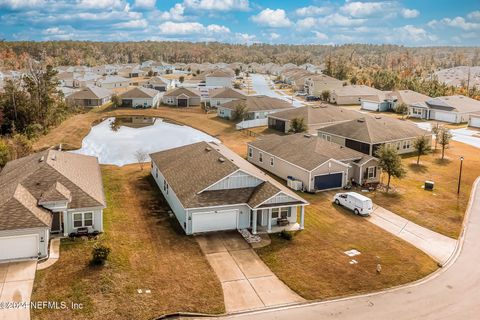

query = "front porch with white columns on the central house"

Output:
[[251, 205, 305, 234]]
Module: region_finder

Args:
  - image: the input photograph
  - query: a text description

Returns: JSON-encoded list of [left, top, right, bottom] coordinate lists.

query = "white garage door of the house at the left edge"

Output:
[[0, 234, 38, 260]]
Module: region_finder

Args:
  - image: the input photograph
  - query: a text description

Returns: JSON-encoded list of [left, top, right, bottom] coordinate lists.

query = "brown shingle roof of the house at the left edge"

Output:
[[0, 150, 106, 230]]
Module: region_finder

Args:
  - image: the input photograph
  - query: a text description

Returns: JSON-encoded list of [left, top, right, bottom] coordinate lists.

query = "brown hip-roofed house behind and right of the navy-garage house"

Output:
[[318, 115, 432, 156]]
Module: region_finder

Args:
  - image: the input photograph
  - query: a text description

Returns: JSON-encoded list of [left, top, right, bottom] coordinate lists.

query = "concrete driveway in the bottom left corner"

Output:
[[0, 260, 37, 320]]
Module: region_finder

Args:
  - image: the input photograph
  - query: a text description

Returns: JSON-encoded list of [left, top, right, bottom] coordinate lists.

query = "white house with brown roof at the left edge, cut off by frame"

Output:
[[0, 149, 106, 260]]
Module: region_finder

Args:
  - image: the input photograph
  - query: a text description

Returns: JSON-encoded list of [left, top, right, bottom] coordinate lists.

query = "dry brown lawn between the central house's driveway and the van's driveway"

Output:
[[257, 193, 437, 299]]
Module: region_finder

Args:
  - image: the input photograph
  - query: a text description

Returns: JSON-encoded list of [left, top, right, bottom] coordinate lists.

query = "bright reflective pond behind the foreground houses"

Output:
[[72, 116, 219, 166]]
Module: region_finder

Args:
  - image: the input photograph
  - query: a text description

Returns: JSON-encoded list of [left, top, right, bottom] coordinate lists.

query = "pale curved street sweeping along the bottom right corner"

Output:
[[221, 178, 480, 320]]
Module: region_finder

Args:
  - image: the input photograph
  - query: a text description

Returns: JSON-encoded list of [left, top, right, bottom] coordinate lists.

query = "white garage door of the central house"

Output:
[[192, 210, 238, 233]]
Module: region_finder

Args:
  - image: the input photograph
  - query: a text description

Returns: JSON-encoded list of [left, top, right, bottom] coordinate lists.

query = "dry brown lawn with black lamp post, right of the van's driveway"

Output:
[[366, 141, 480, 238]]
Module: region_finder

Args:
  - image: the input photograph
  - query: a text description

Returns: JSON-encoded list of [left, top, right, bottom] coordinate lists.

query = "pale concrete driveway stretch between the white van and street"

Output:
[[367, 205, 457, 266]]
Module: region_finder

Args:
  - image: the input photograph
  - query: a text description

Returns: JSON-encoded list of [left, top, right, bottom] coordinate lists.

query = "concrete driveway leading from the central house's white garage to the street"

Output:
[[196, 231, 304, 313]]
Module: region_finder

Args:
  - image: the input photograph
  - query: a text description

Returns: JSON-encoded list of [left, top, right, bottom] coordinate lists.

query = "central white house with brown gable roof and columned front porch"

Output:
[[150, 142, 308, 234]]
